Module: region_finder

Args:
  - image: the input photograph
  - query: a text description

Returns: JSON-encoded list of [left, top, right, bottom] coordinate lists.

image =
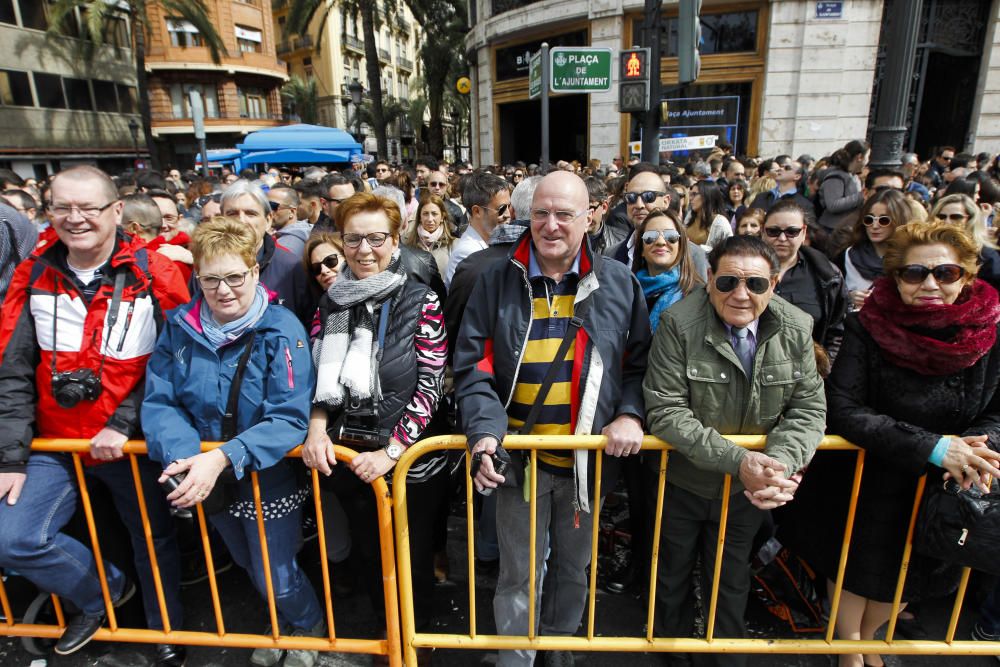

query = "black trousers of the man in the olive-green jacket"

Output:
[[656, 482, 763, 667]]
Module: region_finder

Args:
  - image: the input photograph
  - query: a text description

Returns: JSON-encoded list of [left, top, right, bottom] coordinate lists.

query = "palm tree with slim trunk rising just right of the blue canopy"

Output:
[[285, 0, 396, 157]]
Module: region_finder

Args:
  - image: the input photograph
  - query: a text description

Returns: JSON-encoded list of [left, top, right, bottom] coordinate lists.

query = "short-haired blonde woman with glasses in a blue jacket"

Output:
[[142, 218, 323, 667]]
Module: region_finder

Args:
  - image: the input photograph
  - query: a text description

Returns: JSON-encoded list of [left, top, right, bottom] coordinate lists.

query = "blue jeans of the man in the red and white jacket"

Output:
[[0, 452, 183, 629]]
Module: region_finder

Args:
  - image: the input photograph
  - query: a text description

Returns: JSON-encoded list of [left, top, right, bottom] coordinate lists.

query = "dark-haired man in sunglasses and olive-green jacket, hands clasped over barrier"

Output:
[[643, 236, 826, 666]]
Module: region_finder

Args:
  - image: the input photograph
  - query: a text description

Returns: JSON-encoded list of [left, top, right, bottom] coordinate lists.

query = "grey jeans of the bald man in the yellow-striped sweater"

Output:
[[493, 468, 599, 667]]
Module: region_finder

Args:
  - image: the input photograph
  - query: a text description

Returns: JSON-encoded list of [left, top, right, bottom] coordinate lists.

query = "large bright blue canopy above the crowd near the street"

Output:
[[236, 124, 362, 165]]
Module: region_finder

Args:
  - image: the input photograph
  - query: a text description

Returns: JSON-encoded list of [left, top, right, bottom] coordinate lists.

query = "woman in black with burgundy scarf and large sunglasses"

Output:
[[779, 223, 1000, 667]]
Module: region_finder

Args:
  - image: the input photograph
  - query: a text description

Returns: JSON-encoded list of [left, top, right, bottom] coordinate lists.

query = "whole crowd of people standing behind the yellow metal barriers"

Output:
[[0, 141, 1000, 667]]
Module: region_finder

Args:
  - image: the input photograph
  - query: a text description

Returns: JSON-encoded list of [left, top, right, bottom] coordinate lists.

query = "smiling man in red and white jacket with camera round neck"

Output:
[[0, 166, 188, 666]]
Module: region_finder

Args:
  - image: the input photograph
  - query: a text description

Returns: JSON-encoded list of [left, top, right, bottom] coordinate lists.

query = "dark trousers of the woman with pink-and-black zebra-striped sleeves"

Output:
[[330, 465, 448, 631]]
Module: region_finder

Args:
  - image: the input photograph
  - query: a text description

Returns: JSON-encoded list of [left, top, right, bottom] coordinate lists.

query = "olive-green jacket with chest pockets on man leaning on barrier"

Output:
[[643, 289, 826, 498]]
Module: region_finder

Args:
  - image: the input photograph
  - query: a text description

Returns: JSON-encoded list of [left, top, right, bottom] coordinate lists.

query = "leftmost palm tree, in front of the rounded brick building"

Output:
[[49, 0, 226, 169]]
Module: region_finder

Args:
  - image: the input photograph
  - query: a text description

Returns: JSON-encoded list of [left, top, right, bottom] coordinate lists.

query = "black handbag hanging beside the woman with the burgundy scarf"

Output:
[[913, 479, 1000, 575]]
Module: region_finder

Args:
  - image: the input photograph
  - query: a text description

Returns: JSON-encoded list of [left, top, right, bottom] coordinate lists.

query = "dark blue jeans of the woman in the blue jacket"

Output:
[[209, 462, 323, 632]]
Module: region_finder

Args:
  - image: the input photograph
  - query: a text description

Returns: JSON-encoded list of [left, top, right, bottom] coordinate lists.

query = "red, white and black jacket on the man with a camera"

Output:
[[0, 232, 189, 472]]
